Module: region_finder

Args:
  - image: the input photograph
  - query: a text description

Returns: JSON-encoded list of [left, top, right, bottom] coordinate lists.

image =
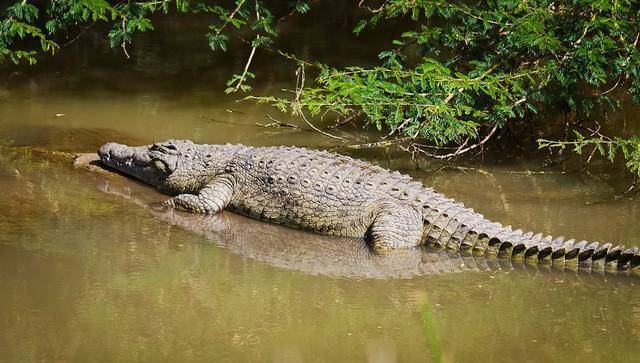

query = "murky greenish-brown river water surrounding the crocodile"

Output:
[[0, 4, 640, 362]]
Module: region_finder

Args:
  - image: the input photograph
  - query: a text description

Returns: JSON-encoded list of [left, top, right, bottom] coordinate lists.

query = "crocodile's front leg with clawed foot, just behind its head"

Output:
[[164, 177, 233, 214]]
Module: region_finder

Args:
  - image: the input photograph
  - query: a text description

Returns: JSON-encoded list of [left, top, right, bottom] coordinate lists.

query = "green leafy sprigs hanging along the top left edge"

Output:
[[0, 0, 310, 62]]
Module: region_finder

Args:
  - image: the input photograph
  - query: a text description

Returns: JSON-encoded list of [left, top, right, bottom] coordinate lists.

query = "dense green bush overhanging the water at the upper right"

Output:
[[259, 0, 640, 176]]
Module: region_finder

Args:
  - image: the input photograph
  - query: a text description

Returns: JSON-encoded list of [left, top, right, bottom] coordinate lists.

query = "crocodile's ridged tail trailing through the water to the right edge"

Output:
[[423, 198, 640, 271]]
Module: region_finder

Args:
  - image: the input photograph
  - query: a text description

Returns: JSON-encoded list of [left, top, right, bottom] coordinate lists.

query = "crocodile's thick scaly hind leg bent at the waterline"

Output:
[[369, 203, 423, 252]]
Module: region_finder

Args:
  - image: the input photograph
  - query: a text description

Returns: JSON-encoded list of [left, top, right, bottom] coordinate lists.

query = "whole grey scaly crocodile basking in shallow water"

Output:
[[98, 140, 640, 270]]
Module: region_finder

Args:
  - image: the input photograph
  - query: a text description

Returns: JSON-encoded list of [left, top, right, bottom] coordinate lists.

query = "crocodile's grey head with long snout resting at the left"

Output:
[[98, 140, 219, 194]]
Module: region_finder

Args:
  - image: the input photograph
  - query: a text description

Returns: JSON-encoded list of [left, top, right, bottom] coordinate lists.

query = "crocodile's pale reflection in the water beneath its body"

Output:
[[86, 165, 638, 286]]
